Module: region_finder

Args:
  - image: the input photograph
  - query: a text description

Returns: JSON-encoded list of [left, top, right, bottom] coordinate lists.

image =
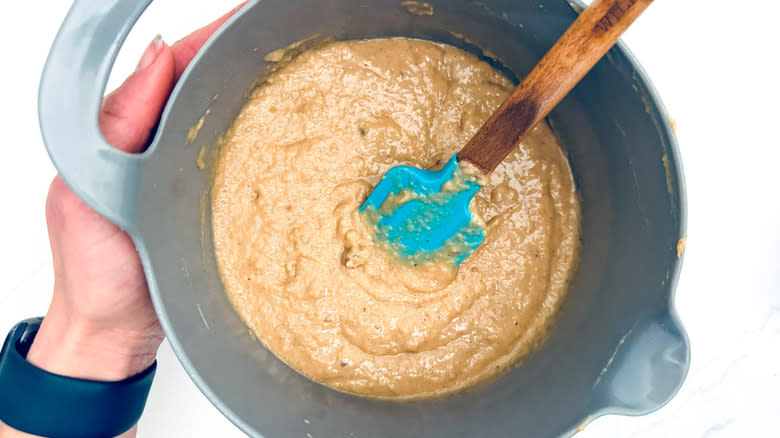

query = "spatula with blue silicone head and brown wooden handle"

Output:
[[360, 0, 653, 265]]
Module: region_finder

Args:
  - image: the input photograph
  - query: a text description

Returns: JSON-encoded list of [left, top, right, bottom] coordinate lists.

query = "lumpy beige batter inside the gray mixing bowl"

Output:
[[212, 39, 580, 399]]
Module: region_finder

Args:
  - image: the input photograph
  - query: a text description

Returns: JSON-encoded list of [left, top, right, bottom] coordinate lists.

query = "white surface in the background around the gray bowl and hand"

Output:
[[0, 0, 780, 438]]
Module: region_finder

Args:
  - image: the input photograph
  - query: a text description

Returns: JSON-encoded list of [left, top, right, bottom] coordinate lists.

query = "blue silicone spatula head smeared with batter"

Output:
[[360, 156, 485, 266]]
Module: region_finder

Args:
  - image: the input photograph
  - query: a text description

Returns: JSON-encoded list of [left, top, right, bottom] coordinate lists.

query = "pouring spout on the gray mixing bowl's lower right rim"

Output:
[[591, 309, 690, 415]]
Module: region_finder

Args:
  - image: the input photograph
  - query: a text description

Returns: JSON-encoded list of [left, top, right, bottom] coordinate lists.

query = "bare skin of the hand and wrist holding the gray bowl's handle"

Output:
[[0, 4, 244, 438]]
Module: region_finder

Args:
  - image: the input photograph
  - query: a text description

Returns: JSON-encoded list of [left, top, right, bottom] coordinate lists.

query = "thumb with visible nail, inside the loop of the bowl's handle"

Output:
[[98, 36, 175, 153]]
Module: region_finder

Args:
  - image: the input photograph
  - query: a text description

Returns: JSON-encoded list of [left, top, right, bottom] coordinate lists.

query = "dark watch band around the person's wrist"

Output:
[[0, 318, 157, 438]]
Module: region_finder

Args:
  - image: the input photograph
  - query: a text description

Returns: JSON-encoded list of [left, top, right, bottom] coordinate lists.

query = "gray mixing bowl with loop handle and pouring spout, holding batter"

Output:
[[40, 0, 690, 438]]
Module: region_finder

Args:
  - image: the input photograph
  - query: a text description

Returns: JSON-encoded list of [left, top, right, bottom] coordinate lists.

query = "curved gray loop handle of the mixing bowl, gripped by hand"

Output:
[[38, 0, 152, 229]]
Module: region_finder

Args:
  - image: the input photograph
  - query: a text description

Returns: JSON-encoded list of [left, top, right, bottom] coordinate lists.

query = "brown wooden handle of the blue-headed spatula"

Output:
[[458, 0, 653, 174]]
